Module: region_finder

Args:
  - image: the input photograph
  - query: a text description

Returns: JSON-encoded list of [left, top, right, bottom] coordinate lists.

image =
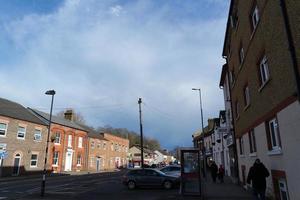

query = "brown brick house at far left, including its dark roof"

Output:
[[0, 98, 47, 177]]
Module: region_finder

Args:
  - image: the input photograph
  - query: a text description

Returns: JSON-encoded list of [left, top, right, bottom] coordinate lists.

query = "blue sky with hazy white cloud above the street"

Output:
[[0, 0, 229, 149]]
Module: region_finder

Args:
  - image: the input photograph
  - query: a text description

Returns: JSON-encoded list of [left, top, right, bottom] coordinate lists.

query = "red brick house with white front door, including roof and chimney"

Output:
[[31, 109, 88, 172]]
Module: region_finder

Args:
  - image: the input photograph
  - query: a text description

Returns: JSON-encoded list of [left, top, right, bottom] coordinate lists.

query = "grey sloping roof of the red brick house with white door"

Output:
[[28, 108, 88, 132]]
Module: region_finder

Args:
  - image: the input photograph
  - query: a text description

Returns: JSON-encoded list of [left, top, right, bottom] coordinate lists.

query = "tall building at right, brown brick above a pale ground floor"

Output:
[[223, 0, 300, 199]]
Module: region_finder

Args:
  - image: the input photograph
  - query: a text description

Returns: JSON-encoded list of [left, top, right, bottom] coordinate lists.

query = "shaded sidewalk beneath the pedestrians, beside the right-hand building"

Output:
[[202, 174, 254, 200]]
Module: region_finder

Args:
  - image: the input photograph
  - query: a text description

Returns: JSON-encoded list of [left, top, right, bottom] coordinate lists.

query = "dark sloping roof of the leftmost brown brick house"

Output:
[[0, 98, 47, 126]]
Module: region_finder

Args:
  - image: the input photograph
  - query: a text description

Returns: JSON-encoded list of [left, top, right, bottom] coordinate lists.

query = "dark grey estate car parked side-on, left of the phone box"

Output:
[[123, 169, 180, 189]]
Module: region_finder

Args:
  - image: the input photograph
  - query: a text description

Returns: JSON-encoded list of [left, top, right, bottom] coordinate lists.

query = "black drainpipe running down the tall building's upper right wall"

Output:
[[280, 0, 300, 103]]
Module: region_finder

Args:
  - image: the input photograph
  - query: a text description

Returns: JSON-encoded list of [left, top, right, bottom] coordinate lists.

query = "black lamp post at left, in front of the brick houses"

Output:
[[41, 90, 55, 197]]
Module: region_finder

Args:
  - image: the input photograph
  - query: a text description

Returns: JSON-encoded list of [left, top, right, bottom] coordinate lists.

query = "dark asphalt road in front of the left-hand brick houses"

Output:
[[0, 171, 183, 200]]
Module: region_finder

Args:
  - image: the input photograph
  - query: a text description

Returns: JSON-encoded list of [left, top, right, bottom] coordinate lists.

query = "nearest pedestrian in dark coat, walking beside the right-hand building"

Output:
[[247, 159, 270, 200]]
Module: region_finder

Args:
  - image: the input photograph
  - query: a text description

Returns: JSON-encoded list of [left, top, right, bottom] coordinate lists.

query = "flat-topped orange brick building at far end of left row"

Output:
[[101, 133, 129, 169]]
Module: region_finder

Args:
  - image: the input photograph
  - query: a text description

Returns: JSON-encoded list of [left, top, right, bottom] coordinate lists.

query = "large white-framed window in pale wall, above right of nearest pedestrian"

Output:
[[266, 117, 281, 150]]
